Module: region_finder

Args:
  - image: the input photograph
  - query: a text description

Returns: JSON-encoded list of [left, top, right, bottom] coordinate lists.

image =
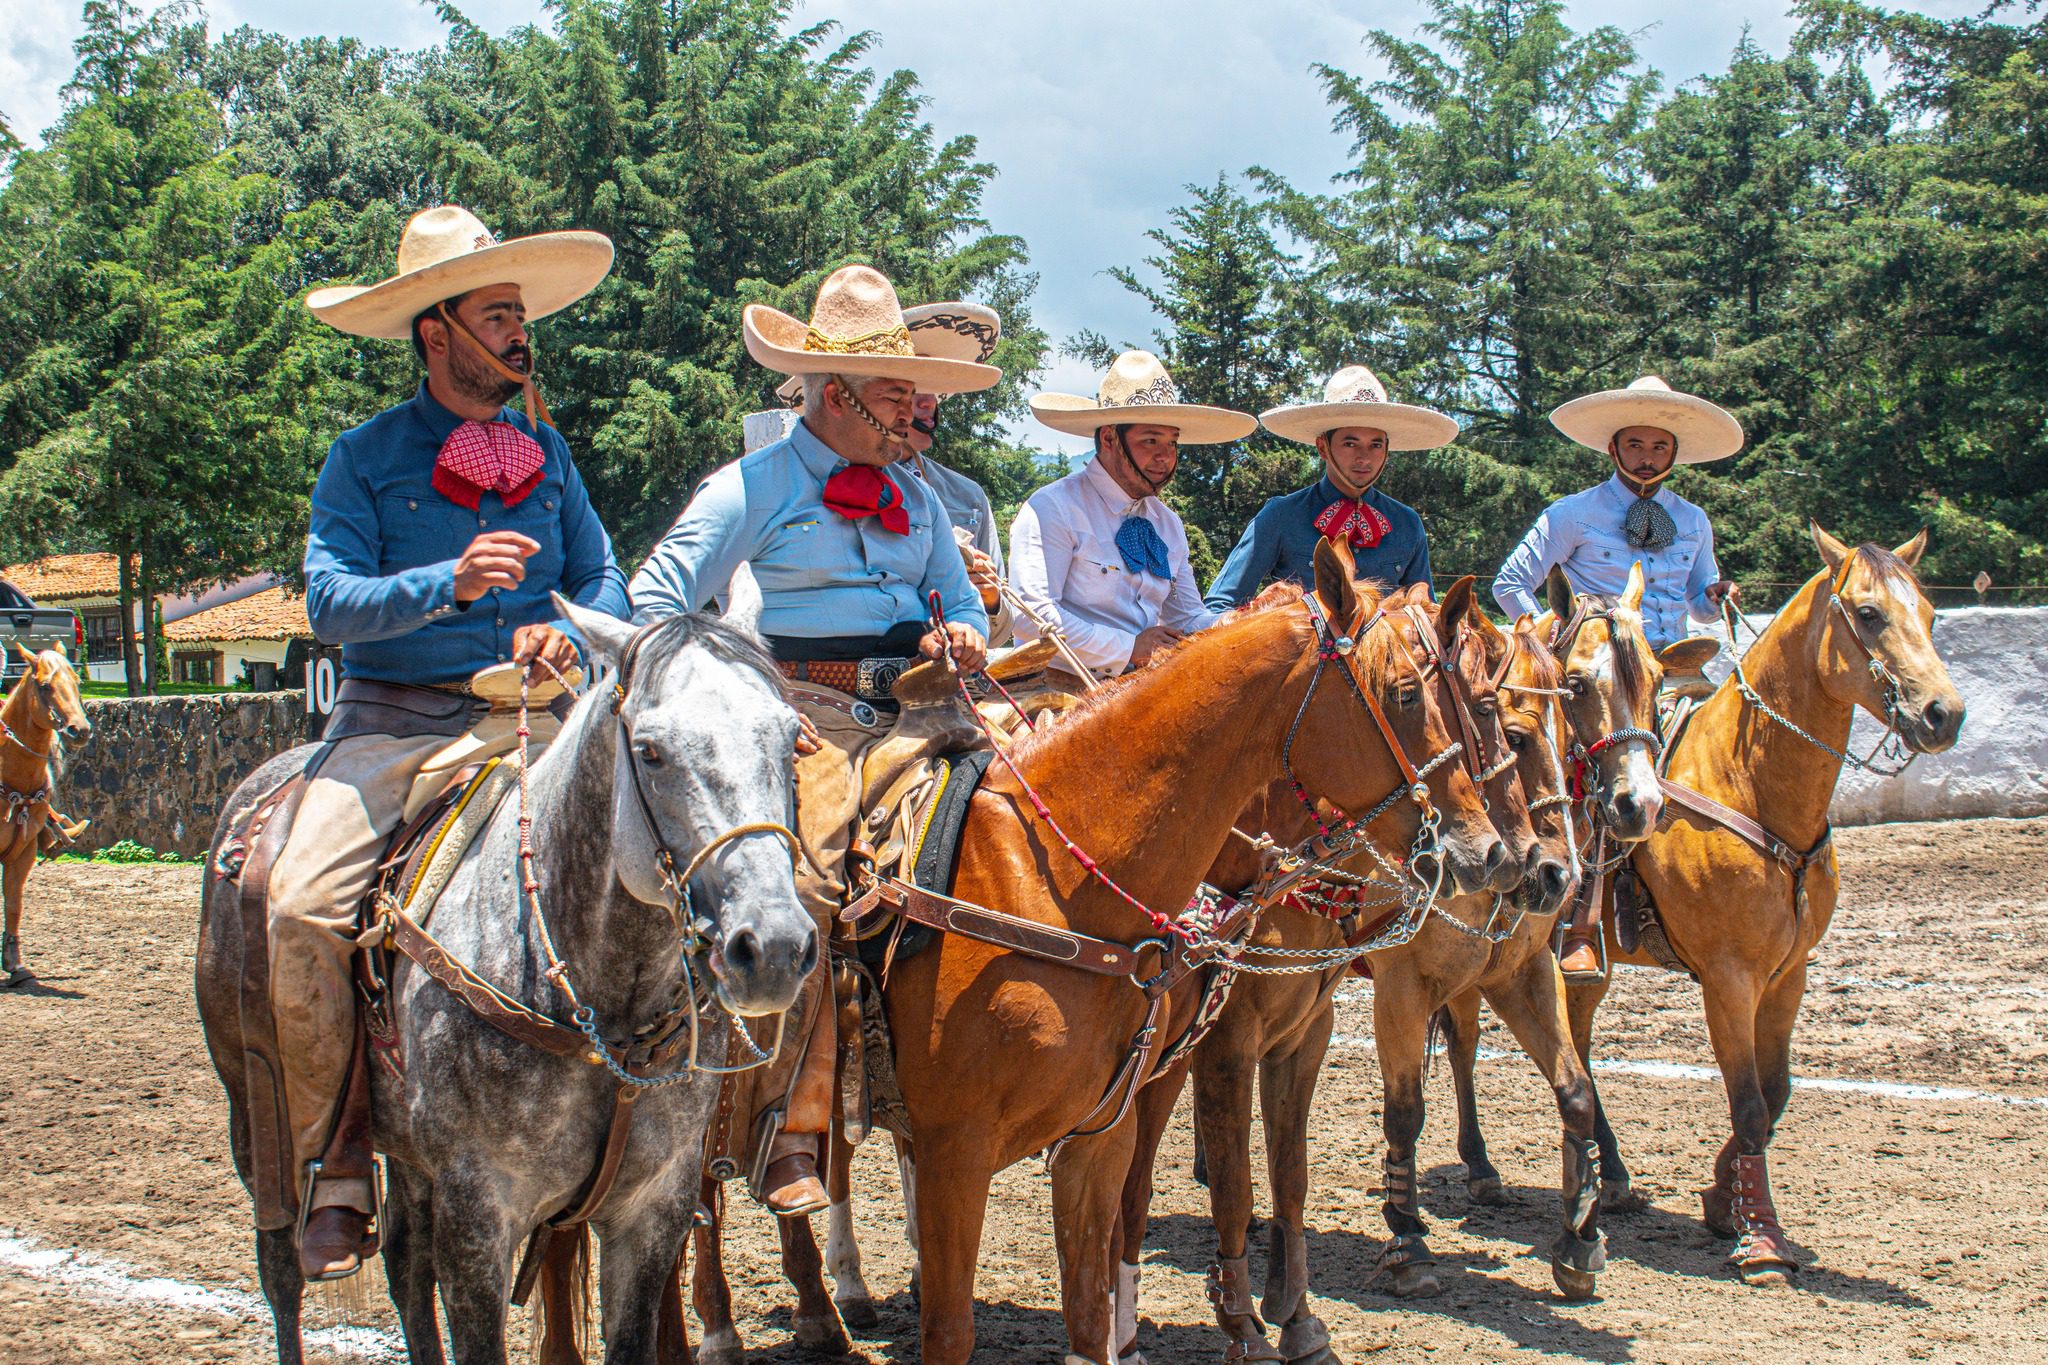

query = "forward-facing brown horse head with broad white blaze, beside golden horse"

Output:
[[1536, 563, 1663, 843]]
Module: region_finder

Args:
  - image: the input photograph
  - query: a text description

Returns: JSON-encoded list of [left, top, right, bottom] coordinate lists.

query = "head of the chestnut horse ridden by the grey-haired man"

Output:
[[1294, 540, 1507, 892]]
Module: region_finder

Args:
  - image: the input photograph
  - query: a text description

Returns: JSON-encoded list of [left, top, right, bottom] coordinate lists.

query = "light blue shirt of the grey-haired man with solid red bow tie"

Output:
[[633, 422, 989, 641]]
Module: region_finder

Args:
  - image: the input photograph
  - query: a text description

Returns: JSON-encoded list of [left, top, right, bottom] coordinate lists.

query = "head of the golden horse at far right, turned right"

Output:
[[1812, 522, 1964, 753]]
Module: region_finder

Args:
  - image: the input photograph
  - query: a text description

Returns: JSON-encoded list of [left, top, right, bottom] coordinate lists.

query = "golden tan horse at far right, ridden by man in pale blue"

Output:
[[1458, 524, 1964, 1283]]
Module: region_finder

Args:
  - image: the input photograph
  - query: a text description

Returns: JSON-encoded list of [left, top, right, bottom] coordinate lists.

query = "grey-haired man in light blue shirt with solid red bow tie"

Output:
[[633, 266, 1001, 1216]]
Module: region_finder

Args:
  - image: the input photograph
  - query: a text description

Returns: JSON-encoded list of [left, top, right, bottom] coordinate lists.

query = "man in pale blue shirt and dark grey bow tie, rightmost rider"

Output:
[[1493, 375, 1743, 980]]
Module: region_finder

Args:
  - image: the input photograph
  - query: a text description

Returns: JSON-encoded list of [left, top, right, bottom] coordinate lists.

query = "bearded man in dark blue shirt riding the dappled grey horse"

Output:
[[268, 207, 629, 1279]]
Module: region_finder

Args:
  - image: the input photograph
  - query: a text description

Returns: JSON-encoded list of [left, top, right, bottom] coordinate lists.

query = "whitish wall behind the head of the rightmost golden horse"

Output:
[[1706, 606, 2048, 825]]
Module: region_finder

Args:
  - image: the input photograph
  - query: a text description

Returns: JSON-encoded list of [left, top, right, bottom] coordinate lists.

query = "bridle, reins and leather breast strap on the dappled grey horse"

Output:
[[518, 622, 799, 1089]]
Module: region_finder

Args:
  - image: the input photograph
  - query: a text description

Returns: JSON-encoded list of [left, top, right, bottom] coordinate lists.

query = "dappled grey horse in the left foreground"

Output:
[[197, 596, 819, 1365]]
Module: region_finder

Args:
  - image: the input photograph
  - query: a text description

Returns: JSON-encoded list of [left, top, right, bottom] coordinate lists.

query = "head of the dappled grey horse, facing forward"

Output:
[[555, 596, 819, 1015]]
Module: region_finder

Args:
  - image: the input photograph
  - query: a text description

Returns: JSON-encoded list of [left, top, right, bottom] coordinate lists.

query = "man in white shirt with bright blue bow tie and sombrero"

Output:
[[1010, 350, 1257, 677]]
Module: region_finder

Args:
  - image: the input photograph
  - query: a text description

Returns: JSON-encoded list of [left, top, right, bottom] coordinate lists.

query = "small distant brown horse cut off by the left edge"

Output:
[[0, 645, 92, 986]]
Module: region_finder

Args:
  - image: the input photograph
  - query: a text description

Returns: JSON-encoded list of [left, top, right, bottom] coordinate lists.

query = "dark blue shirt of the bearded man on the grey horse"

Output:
[[305, 381, 633, 684]]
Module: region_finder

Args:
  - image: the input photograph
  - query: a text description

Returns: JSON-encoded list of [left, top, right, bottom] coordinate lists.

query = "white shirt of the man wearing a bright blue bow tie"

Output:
[[1010, 458, 1217, 673]]
